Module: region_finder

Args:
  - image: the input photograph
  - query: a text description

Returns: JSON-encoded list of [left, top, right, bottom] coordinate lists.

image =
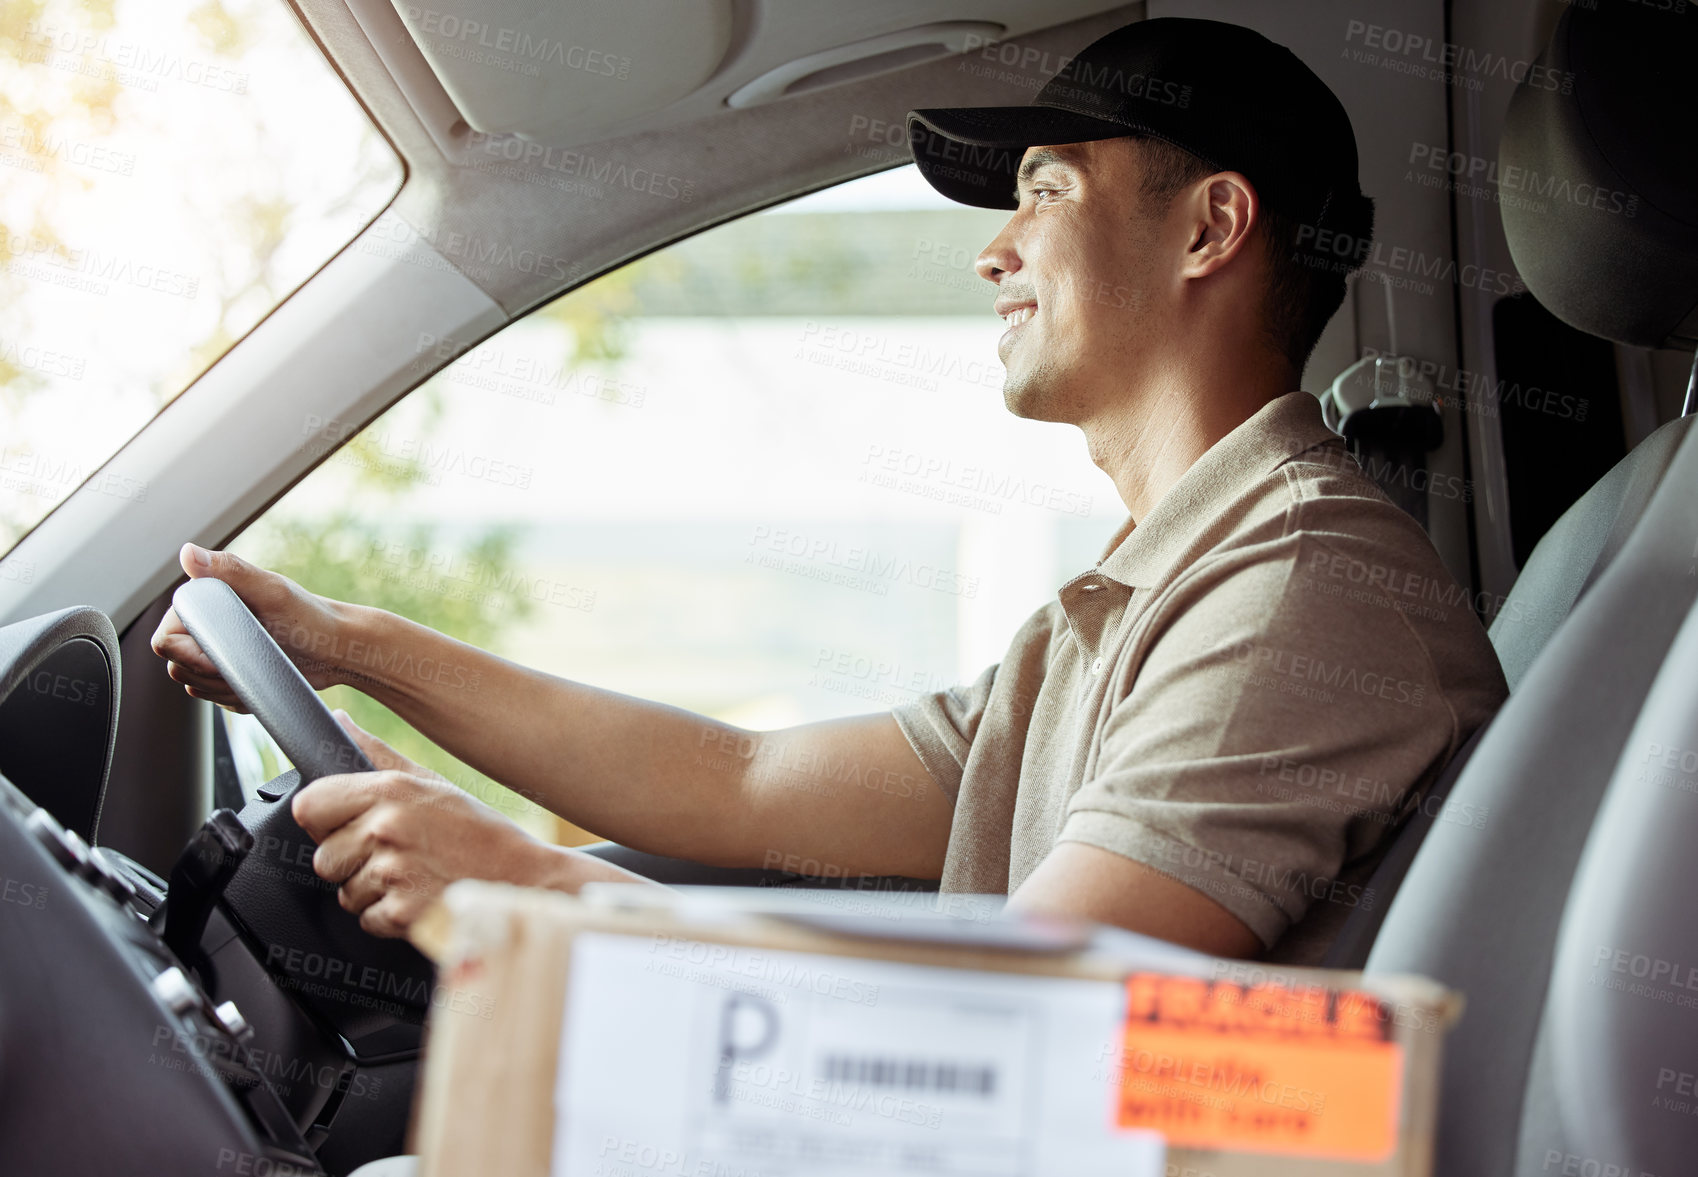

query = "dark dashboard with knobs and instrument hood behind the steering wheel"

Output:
[[0, 608, 421, 1177]]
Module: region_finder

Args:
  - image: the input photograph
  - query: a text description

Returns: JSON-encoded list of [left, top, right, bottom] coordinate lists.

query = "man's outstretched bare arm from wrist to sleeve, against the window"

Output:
[[324, 606, 949, 875]]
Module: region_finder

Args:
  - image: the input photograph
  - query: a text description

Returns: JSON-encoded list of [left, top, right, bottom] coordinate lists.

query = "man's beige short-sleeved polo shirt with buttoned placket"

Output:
[[895, 392, 1508, 963]]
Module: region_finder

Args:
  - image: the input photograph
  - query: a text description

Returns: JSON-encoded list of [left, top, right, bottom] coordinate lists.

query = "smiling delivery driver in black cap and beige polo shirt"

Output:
[[153, 19, 1506, 963]]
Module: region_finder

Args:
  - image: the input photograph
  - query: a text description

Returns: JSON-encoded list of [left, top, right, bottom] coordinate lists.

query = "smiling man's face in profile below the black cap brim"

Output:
[[976, 139, 1184, 423]]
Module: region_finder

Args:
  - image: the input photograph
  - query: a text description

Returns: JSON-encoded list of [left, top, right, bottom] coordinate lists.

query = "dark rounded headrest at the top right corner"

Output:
[[1498, 0, 1698, 348]]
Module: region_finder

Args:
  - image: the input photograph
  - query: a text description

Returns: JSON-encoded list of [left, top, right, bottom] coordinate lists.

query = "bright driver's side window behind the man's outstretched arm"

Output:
[[233, 166, 1124, 842]]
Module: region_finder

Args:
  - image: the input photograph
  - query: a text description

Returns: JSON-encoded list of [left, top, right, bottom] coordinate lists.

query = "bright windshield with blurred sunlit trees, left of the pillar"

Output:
[[0, 0, 402, 554]]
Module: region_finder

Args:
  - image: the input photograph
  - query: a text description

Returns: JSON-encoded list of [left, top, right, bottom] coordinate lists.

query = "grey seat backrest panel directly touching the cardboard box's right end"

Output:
[[1365, 428, 1698, 1177]]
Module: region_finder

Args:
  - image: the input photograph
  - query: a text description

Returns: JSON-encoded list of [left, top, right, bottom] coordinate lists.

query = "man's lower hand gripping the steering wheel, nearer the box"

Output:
[[294, 710, 562, 936]]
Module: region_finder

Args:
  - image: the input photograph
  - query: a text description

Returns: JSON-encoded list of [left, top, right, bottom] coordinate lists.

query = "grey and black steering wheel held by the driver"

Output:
[[171, 577, 435, 1056]]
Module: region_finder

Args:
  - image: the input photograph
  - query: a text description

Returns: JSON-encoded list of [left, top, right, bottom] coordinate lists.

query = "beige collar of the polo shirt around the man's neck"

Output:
[[1097, 391, 1345, 588]]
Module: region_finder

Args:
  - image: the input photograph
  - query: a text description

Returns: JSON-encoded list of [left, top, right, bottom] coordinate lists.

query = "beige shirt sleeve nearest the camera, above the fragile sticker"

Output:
[[1058, 540, 1457, 948]]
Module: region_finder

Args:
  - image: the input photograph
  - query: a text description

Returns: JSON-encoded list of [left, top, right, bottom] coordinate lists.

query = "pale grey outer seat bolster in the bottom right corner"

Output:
[[1548, 584, 1698, 1174]]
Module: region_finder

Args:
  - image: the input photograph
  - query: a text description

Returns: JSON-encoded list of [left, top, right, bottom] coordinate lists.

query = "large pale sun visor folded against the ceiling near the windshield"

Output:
[[396, 0, 732, 143]]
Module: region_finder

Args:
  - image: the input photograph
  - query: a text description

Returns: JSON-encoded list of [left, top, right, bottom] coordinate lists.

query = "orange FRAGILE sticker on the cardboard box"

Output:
[[1116, 973, 1403, 1162]]
